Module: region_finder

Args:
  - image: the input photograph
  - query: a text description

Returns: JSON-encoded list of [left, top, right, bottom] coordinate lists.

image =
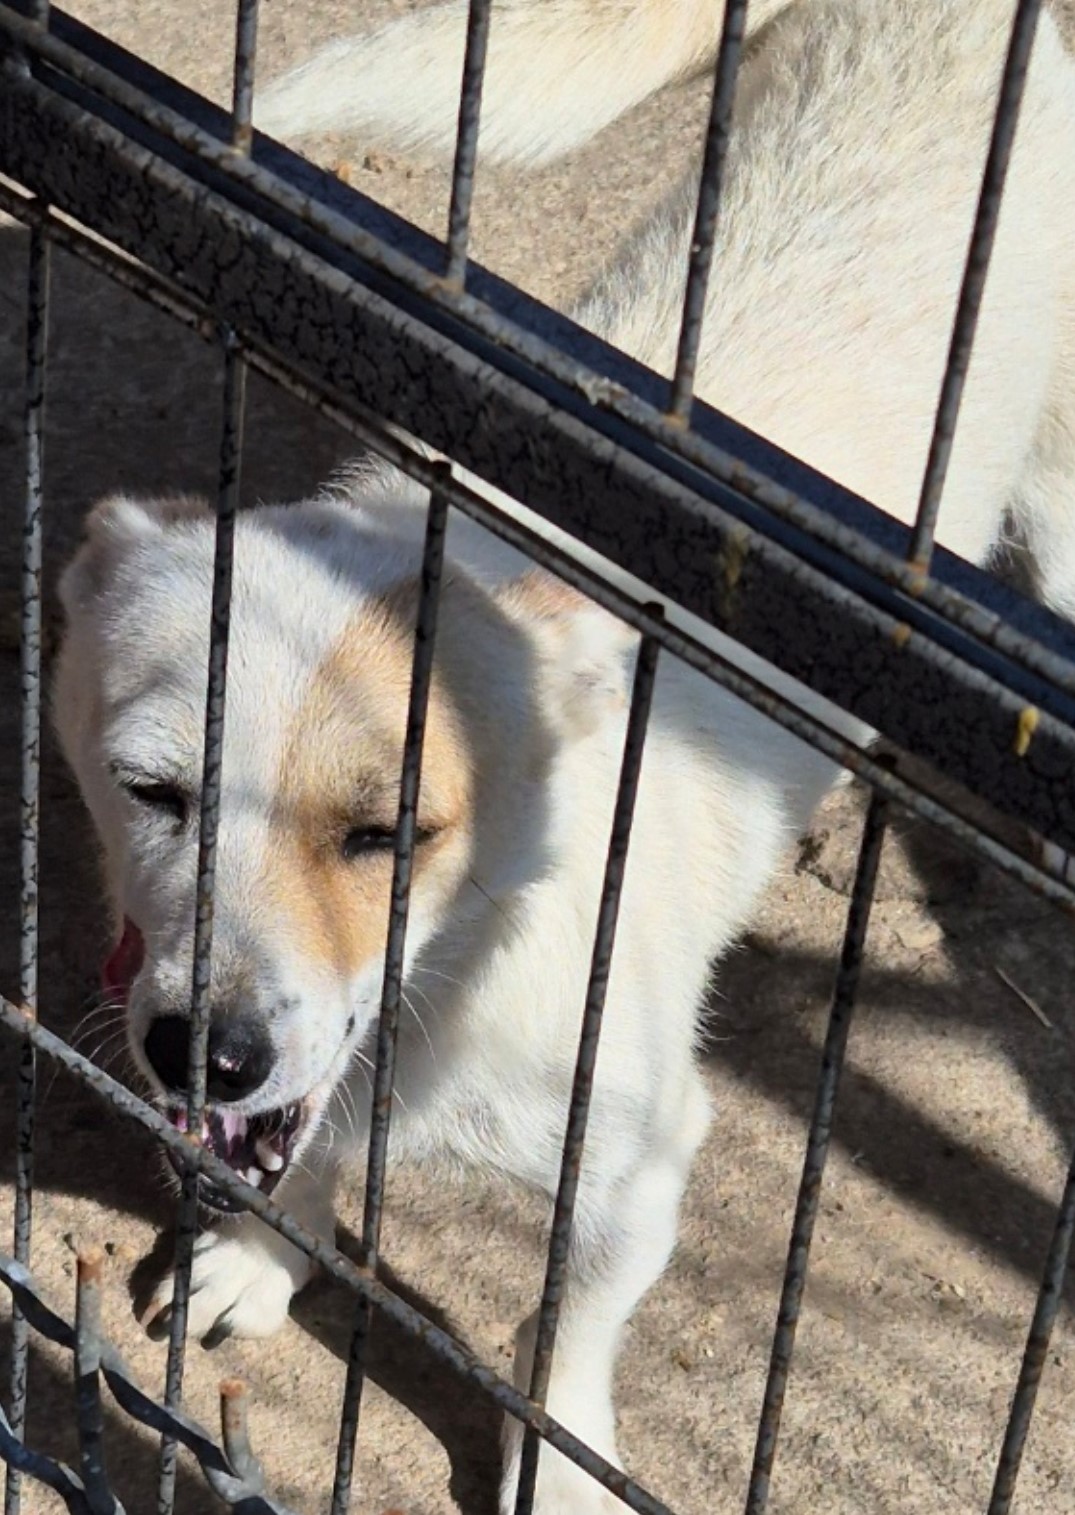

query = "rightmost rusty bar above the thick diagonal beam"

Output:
[[908, 0, 1042, 574]]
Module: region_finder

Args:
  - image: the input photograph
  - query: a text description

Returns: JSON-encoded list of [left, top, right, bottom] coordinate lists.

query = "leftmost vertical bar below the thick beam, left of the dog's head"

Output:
[[5, 210, 50, 1515]]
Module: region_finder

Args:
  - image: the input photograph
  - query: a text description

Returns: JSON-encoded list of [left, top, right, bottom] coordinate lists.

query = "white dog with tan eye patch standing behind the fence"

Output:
[[56, 0, 1075, 1515]]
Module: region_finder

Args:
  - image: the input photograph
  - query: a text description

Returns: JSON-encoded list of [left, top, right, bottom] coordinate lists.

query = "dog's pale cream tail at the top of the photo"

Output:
[[254, 0, 787, 164]]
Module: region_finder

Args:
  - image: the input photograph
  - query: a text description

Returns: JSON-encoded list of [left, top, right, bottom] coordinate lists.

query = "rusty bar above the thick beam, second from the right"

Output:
[[668, 0, 748, 426]]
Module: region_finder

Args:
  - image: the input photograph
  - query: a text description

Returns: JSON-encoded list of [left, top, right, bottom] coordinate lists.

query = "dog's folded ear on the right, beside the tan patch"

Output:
[[497, 568, 637, 736]]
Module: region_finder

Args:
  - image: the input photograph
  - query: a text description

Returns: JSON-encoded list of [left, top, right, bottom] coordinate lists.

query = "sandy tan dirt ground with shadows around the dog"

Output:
[[0, 0, 1075, 1515]]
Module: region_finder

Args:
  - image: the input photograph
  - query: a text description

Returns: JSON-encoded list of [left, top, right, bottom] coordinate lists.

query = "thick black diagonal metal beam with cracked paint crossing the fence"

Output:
[[0, 2, 1075, 847]]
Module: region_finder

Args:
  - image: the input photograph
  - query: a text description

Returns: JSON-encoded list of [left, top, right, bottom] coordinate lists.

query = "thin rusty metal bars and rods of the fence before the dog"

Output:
[[0, 0, 1075, 1515]]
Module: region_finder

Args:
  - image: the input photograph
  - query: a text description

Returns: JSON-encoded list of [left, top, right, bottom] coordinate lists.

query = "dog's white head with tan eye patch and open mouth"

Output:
[[55, 481, 627, 1204]]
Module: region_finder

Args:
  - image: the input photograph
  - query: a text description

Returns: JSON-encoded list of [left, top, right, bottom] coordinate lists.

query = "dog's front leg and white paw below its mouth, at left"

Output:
[[144, 1168, 335, 1341]]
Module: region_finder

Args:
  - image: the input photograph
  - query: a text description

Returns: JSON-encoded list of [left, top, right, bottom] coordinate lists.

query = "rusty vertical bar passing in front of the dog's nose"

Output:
[[157, 0, 257, 1515]]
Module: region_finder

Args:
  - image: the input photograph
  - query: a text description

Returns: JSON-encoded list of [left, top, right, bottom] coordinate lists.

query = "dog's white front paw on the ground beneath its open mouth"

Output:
[[142, 1217, 313, 1345]]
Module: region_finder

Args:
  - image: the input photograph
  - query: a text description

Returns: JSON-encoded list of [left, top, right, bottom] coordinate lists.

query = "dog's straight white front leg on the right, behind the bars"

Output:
[[501, 1070, 709, 1515]]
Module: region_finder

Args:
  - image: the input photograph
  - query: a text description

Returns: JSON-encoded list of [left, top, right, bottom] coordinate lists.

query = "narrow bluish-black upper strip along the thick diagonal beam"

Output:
[[0, 0, 1075, 709]]
